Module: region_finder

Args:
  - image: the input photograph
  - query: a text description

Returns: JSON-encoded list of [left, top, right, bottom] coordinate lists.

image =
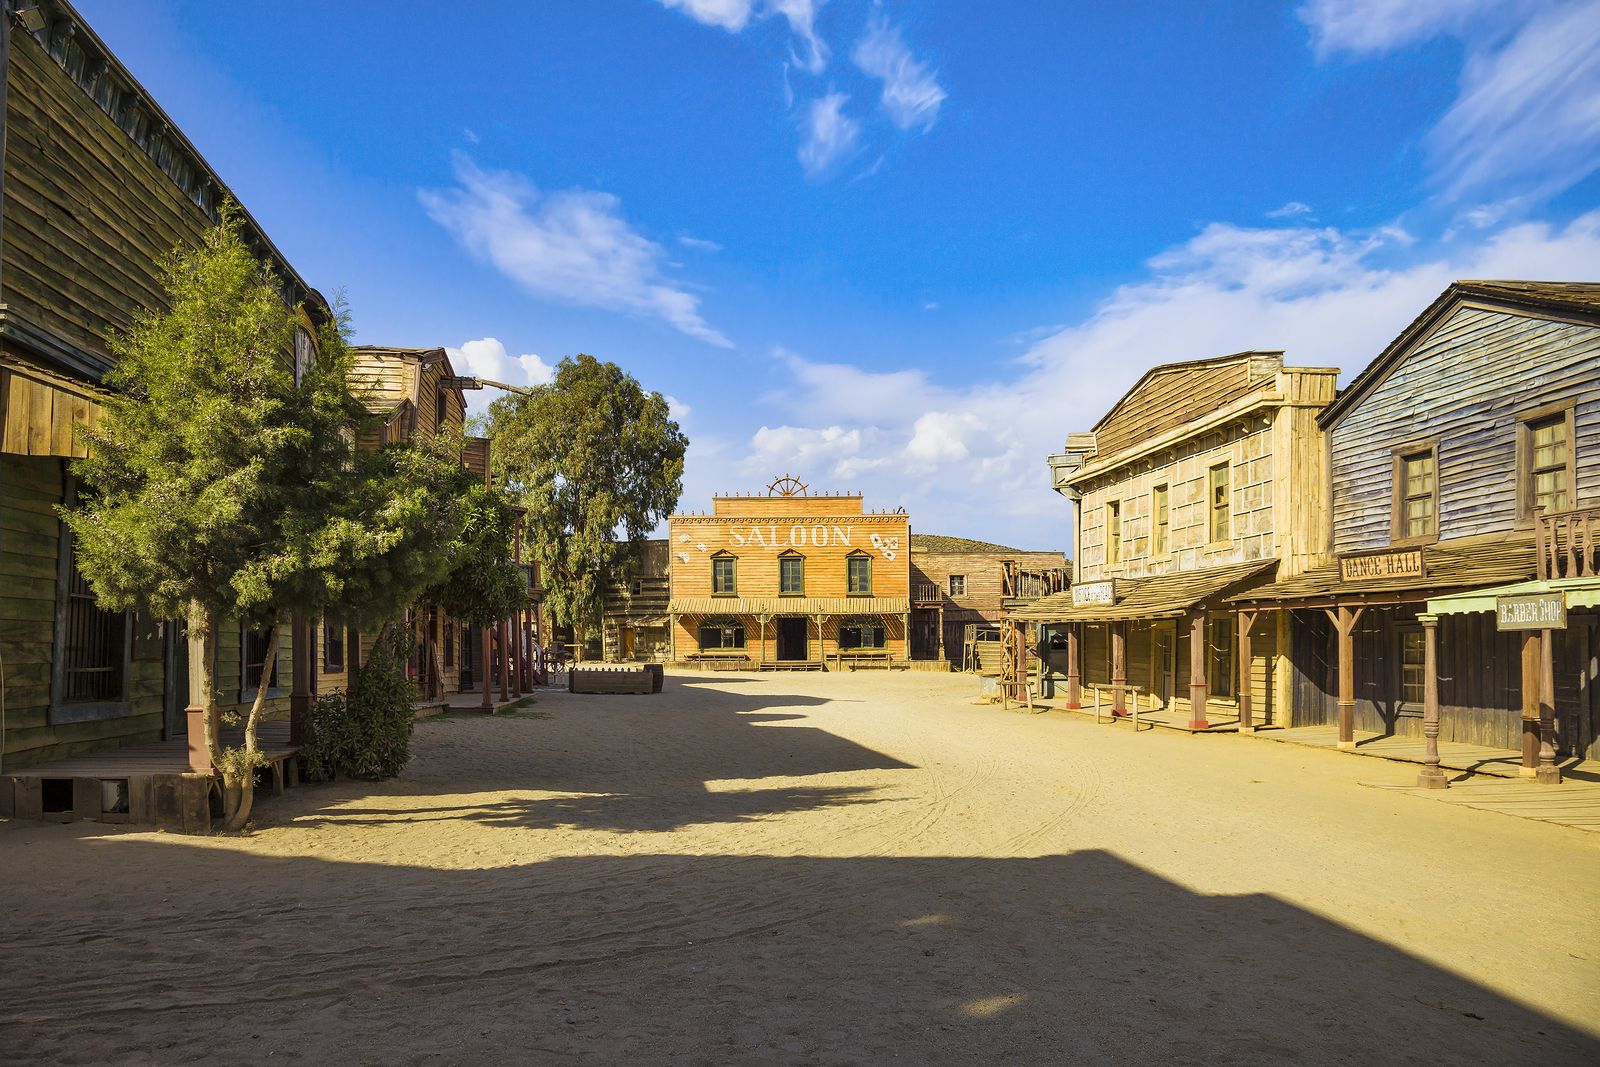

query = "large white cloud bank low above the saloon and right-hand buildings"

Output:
[[691, 211, 1600, 547]]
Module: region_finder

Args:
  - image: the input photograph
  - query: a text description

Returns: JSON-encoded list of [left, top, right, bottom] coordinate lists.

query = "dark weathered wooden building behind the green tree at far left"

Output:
[[0, 0, 328, 777]]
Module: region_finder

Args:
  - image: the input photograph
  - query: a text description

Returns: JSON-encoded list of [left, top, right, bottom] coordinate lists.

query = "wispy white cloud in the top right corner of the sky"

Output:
[[1299, 0, 1600, 198]]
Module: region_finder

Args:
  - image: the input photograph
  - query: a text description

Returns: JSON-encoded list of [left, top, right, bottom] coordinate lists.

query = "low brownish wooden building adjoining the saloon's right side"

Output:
[[910, 533, 1069, 669]]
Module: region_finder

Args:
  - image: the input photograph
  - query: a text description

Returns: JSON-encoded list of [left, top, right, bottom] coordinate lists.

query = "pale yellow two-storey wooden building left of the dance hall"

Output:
[[1008, 352, 1338, 729]]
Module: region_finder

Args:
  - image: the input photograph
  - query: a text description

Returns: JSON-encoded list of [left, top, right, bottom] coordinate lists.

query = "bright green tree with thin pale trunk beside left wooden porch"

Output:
[[62, 214, 461, 829]]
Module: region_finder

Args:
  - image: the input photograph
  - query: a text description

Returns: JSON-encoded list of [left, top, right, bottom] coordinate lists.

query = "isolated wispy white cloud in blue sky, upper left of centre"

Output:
[[418, 155, 733, 347]]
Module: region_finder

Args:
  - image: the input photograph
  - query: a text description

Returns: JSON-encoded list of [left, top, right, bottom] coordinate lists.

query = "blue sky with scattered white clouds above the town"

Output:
[[78, 0, 1600, 549]]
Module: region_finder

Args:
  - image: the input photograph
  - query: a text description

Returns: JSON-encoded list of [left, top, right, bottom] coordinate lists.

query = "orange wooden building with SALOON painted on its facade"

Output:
[[667, 478, 910, 670]]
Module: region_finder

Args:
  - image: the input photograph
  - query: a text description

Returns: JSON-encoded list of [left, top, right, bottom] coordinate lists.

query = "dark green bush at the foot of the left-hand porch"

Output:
[[301, 629, 416, 782]]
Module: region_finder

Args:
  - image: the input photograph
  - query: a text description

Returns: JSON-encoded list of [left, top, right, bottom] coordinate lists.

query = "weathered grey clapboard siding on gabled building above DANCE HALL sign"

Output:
[[1330, 306, 1600, 552]]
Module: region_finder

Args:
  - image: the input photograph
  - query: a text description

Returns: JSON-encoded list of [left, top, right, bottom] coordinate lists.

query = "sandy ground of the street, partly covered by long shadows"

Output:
[[0, 673, 1600, 1064]]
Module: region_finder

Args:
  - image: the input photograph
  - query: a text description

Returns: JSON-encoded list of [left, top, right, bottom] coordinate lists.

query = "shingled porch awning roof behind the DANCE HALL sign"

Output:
[[1227, 531, 1536, 608]]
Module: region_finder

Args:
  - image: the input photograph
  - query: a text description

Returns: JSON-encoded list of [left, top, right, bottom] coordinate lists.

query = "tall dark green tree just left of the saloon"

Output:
[[490, 355, 688, 648]]
